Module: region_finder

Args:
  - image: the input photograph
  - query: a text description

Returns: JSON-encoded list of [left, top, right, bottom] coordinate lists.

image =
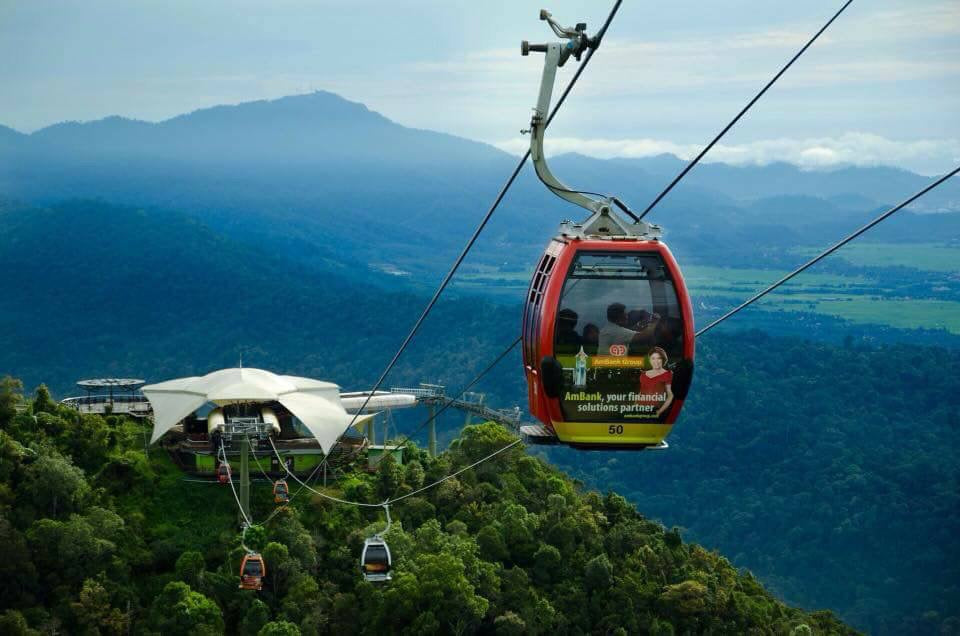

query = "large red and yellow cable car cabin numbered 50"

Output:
[[523, 234, 694, 450]]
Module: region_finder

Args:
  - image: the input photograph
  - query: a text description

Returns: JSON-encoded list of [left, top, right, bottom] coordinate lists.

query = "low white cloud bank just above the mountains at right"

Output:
[[495, 132, 960, 175]]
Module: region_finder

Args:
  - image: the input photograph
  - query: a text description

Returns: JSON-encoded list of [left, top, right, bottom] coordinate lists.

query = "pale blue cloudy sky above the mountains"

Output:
[[0, 0, 960, 174]]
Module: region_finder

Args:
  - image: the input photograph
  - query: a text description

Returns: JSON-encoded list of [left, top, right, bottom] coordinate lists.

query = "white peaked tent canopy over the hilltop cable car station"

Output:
[[141, 368, 373, 453]]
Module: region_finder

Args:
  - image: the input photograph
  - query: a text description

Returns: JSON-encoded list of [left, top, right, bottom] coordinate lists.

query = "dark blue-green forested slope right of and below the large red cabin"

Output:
[[547, 331, 960, 634]]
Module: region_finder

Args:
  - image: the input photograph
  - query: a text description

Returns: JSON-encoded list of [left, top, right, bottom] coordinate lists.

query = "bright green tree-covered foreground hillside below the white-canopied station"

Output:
[[0, 378, 852, 636]]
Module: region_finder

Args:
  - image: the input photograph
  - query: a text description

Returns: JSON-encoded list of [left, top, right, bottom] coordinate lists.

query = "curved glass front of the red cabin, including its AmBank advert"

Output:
[[554, 252, 683, 422]]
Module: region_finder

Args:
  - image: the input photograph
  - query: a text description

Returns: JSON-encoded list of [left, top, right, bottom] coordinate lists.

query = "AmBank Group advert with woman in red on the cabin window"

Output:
[[557, 345, 673, 422]]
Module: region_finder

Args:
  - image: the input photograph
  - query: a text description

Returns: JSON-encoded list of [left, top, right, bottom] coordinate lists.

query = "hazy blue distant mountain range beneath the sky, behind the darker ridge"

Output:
[[0, 92, 960, 281]]
